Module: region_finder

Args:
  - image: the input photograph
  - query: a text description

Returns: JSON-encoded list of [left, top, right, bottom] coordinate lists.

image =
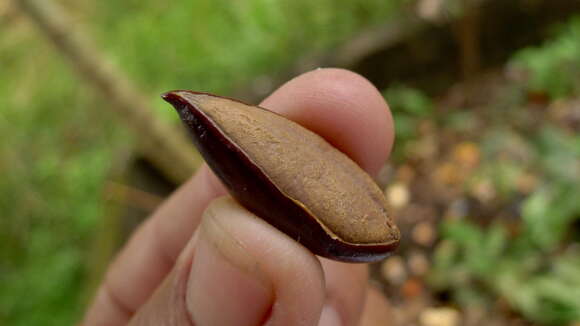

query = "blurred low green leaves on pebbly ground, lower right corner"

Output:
[[431, 216, 580, 325]]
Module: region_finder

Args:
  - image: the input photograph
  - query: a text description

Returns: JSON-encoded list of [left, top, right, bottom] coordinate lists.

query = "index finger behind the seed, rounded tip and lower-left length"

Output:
[[87, 69, 393, 325]]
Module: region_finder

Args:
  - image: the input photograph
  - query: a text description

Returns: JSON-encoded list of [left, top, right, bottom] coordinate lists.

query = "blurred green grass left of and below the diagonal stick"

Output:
[[0, 38, 124, 325]]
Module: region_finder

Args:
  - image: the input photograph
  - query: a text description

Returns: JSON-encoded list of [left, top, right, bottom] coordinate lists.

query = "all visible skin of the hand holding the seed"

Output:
[[82, 69, 393, 326]]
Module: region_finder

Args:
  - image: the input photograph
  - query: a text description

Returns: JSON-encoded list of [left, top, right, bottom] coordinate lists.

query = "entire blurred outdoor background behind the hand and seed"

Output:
[[0, 0, 580, 326]]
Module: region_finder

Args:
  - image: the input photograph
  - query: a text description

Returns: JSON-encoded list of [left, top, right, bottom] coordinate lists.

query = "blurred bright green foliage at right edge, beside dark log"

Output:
[[513, 17, 580, 98]]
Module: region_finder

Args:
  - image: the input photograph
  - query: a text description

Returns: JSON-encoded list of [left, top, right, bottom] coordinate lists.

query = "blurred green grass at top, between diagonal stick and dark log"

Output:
[[91, 0, 405, 119]]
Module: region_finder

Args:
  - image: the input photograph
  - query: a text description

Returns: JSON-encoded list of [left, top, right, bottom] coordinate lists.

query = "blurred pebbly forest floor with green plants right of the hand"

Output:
[[372, 65, 580, 326]]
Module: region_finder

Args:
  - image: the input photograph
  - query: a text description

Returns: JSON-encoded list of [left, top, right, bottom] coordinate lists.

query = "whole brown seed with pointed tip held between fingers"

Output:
[[163, 91, 399, 262]]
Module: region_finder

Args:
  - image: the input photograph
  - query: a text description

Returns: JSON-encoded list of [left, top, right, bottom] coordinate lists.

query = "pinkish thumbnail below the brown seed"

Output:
[[187, 211, 273, 326]]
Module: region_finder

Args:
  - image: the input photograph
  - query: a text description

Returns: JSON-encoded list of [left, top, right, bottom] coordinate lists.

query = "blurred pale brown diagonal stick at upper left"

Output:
[[16, 0, 201, 183]]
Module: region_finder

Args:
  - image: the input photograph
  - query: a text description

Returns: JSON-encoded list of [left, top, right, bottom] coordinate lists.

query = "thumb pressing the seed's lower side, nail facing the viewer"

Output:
[[131, 198, 325, 326]]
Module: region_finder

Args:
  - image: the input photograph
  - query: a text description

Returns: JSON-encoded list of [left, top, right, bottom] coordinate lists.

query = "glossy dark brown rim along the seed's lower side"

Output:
[[162, 90, 399, 263]]
